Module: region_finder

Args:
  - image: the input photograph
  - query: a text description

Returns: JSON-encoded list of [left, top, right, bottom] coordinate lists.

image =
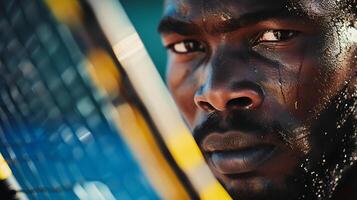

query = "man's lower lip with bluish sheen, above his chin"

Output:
[[210, 146, 275, 174]]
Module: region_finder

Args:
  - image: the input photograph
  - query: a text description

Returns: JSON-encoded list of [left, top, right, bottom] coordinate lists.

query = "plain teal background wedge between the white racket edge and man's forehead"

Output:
[[120, 0, 166, 77]]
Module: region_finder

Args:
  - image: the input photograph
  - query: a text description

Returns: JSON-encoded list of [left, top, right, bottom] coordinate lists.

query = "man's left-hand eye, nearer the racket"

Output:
[[167, 40, 206, 54]]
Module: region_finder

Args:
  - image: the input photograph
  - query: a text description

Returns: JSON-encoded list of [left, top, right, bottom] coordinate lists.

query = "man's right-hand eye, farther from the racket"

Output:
[[254, 30, 299, 45]]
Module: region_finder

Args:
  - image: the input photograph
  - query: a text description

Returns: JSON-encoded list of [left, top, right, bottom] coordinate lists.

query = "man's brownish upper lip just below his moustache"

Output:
[[201, 131, 274, 153]]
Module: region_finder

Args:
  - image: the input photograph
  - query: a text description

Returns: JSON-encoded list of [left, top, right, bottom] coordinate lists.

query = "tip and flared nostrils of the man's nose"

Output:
[[194, 83, 264, 112]]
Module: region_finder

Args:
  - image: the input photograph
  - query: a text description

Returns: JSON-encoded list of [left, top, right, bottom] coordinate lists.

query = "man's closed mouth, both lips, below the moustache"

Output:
[[202, 132, 277, 175]]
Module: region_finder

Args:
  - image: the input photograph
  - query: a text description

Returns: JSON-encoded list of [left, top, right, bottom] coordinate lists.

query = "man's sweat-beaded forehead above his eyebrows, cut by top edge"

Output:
[[164, 0, 339, 20]]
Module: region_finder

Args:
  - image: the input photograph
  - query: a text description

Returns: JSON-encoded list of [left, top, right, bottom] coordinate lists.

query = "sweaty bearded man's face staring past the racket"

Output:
[[159, 0, 357, 200]]
